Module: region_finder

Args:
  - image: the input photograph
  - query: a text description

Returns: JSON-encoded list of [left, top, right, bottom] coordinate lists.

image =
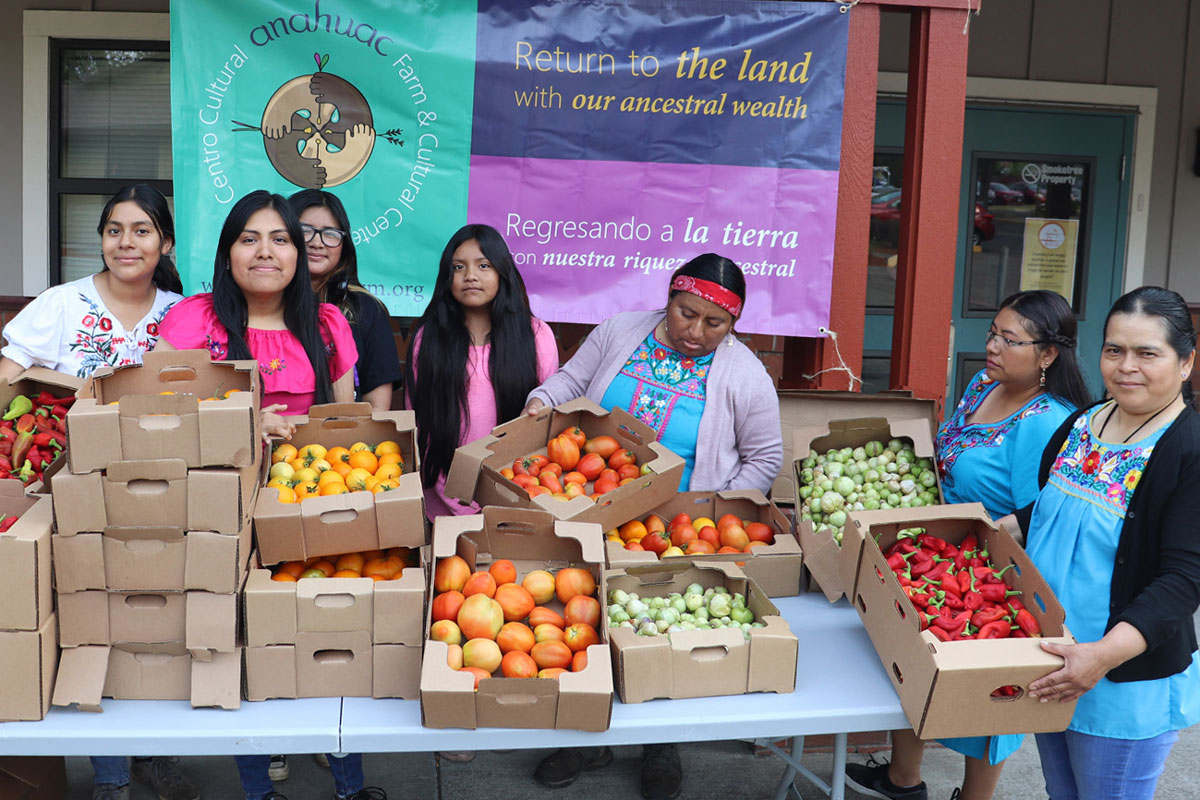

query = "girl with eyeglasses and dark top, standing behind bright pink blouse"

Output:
[[288, 188, 403, 411]]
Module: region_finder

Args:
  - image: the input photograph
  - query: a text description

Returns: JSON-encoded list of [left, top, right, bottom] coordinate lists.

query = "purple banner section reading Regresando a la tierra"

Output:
[[467, 156, 838, 337]]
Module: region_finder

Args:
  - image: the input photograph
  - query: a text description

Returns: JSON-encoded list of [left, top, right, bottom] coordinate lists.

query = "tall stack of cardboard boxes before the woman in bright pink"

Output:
[[50, 350, 263, 710]]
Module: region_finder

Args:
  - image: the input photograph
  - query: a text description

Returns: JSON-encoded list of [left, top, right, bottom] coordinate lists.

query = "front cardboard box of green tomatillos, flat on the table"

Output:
[[605, 561, 799, 703]]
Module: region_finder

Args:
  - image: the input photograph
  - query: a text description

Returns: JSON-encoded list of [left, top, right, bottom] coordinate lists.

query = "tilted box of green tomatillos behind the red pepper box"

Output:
[[792, 417, 942, 602]]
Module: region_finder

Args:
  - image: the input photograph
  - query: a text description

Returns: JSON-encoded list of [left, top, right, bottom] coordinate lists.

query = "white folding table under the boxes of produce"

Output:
[[0, 594, 908, 800]]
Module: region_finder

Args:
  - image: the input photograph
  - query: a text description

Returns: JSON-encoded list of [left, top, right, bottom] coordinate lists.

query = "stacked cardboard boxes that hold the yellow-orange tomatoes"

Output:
[[245, 403, 428, 700]]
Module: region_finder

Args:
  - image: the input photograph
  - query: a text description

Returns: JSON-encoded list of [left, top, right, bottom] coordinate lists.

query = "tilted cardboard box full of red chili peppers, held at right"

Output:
[[846, 503, 1075, 739]]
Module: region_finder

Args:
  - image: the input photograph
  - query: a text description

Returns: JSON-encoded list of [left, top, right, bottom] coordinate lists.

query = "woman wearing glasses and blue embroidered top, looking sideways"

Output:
[[846, 290, 1090, 800]]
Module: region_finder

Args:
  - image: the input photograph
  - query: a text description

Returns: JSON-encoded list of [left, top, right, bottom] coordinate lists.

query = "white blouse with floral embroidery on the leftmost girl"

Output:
[[0, 275, 181, 378]]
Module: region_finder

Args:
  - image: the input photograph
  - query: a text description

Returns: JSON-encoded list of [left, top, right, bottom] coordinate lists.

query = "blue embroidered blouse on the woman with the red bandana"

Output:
[[601, 331, 713, 492]]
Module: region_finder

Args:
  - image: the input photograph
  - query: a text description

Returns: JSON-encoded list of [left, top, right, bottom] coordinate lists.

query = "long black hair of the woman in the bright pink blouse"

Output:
[[212, 190, 334, 403]]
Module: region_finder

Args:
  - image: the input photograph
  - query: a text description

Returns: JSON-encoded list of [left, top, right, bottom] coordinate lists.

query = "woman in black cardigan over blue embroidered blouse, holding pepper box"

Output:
[[1018, 287, 1200, 800]]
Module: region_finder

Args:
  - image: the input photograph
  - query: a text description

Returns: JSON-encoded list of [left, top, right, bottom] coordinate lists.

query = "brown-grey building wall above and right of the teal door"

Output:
[[880, 0, 1200, 302]]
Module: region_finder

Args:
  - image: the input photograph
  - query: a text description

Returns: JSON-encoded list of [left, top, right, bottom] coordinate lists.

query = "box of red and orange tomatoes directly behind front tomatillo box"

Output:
[[605, 489, 800, 597]]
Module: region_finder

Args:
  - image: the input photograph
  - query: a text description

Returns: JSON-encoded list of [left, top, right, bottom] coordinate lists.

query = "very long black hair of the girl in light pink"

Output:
[[404, 224, 538, 486]]
